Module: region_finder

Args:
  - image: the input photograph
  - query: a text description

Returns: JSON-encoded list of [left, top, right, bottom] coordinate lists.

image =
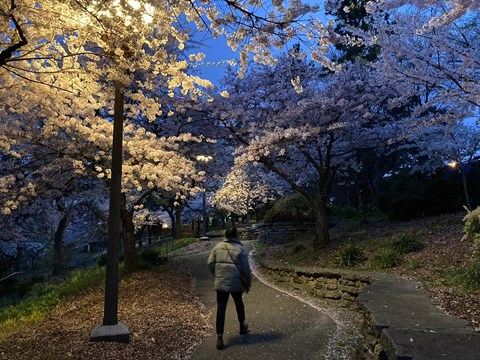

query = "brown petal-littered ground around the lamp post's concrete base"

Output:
[[0, 269, 210, 360]]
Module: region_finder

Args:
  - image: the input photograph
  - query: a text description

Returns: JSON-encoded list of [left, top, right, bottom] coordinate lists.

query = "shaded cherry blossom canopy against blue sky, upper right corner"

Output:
[[348, 2, 480, 131]]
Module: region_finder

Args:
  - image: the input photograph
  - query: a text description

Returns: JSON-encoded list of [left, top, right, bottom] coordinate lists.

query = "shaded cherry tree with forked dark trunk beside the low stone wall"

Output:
[[210, 52, 400, 250]]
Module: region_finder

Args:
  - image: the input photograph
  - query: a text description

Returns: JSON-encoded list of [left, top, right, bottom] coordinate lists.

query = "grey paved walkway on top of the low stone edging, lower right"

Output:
[[357, 273, 480, 360]]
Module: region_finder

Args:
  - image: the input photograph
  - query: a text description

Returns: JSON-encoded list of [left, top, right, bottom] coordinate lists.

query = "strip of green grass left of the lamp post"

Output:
[[0, 266, 105, 341]]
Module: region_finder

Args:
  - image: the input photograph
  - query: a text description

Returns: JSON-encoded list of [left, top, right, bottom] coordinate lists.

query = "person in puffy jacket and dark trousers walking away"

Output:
[[208, 227, 252, 350]]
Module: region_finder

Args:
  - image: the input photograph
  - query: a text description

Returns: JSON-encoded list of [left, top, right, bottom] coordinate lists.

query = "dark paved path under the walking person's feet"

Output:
[[178, 242, 336, 360]]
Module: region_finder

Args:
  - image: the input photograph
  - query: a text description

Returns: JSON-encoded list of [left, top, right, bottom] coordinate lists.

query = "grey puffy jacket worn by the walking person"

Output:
[[208, 239, 252, 292]]
